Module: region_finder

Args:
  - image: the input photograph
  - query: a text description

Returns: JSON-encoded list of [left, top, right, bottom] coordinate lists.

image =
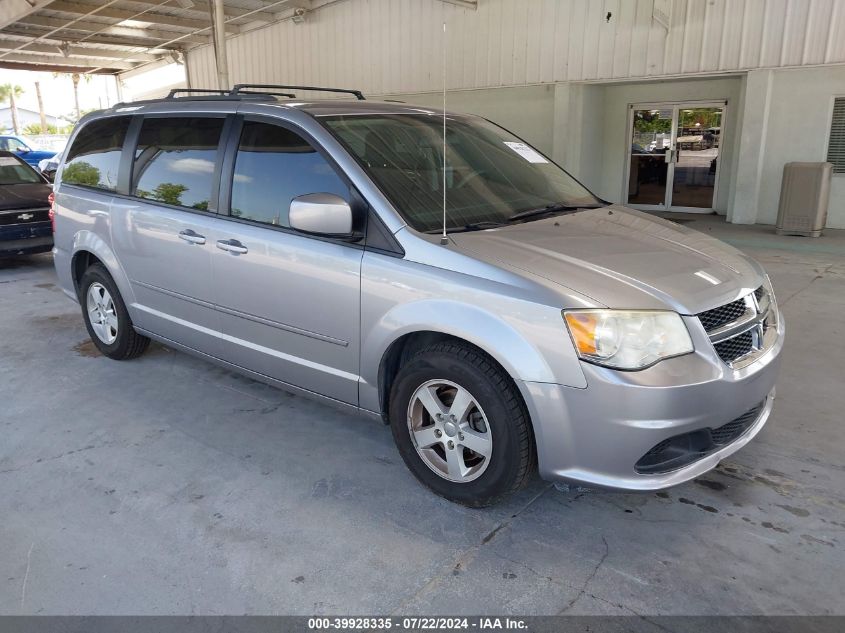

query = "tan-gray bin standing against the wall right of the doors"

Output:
[[776, 163, 833, 237]]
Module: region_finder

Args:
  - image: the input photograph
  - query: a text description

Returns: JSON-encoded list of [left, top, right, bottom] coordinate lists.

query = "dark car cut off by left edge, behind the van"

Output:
[[0, 151, 53, 260]]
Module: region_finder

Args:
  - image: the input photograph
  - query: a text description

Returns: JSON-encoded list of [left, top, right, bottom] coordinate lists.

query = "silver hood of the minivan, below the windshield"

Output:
[[450, 205, 765, 315]]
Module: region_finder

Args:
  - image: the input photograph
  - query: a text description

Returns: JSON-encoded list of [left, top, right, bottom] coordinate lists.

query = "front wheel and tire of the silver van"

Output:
[[389, 341, 536, 507]]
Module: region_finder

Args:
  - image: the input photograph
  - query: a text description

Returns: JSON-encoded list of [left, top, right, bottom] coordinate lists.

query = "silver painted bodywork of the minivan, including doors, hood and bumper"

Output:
[[54, 99, 784, 490]]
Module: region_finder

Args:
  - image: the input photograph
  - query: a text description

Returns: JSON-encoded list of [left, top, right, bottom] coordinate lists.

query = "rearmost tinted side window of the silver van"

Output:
[[62, 117, 129, 191]]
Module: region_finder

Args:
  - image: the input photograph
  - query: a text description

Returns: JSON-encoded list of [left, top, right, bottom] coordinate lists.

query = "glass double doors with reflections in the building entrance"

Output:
[[627, 103, 725, 213]]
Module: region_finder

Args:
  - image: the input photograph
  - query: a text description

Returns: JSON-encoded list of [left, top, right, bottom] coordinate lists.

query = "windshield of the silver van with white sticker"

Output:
[[321, 114, 602, 232]]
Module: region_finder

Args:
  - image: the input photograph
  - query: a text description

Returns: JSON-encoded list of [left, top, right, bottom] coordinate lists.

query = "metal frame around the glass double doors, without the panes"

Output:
[[621, 99, 728, 213]]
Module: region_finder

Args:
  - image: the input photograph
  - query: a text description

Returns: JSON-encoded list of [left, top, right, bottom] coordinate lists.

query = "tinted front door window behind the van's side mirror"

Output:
[[232, 121, 349, 226]]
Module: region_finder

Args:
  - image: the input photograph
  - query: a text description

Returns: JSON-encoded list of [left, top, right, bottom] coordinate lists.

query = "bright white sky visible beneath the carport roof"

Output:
[[0, 68, 118, 117]]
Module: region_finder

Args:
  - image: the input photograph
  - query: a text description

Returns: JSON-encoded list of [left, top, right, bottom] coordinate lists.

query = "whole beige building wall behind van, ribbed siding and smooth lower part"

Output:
[[187, 0, 845, 227]]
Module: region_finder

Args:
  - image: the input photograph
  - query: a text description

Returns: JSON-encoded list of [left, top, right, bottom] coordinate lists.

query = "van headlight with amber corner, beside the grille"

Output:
[[563, 310, 694, 369]]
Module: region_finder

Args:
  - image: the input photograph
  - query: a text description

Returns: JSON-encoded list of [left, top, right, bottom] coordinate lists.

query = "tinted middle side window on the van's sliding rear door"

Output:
[[132, 118, 223, 211]]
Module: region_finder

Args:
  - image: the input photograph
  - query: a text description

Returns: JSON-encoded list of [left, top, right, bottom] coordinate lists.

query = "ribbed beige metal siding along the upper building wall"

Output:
[[188, 0, 845, 95]]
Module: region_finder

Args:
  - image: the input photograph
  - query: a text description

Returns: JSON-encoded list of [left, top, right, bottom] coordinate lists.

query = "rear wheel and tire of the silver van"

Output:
[[79, 264, 150, 360]]
